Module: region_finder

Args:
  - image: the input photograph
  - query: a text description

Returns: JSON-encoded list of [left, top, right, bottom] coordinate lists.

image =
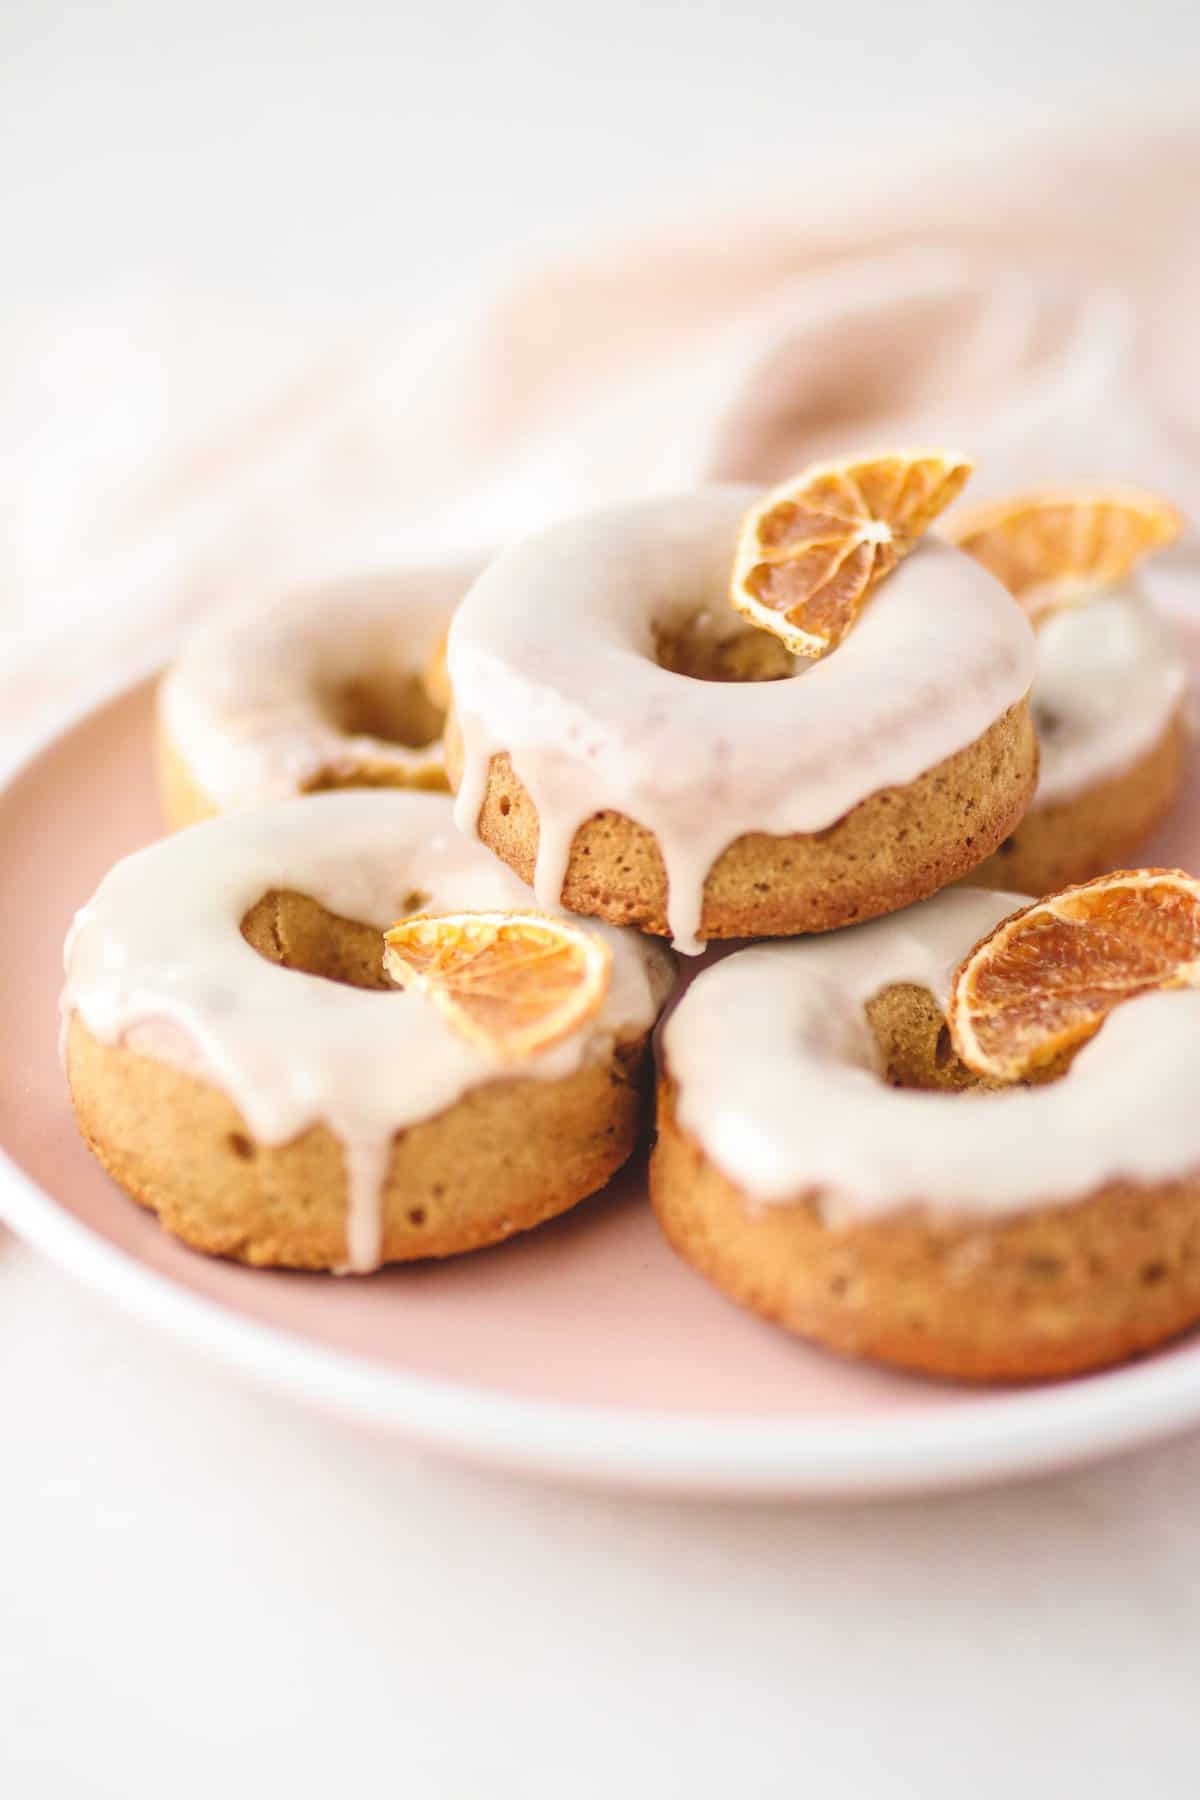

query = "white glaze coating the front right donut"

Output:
[[664, 887, 1200, 1224]]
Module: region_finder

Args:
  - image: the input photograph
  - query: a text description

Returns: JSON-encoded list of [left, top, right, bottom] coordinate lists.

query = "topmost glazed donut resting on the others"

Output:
[[446, 486, 1036, 952]]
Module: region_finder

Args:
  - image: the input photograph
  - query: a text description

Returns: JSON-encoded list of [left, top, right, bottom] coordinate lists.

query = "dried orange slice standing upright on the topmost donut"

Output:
[[730, 450, 972, 657]]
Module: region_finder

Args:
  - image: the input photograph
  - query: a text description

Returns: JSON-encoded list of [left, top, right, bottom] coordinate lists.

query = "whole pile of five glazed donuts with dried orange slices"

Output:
[[63, 452, 1200, 1381]]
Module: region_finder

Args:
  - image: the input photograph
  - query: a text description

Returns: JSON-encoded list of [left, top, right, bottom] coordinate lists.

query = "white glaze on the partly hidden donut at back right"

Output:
[[1033, 580, 1187, 806]]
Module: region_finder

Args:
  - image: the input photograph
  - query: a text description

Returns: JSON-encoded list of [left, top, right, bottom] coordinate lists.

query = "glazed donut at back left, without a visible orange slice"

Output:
[[158, 569, 473, 828]]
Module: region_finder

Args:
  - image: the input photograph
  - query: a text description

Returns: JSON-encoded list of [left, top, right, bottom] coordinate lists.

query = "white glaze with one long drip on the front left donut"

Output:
[[63, 790, 671, 1269]]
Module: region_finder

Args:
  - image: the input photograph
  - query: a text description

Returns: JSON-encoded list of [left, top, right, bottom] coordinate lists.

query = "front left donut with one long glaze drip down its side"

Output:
[[63, 790, 671, 1271]]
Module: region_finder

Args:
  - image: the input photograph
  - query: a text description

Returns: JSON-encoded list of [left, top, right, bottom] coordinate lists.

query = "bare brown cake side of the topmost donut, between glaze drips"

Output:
[[446, 700, 1038, 938]]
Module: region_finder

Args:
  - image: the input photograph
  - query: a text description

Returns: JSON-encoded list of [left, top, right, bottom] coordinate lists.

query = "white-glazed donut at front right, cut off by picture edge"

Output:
[[651, 889, 1200, 1381]]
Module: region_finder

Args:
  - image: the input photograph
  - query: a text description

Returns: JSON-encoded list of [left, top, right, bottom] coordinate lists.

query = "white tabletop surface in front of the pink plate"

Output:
[[0, 1242, 1200, 1800]]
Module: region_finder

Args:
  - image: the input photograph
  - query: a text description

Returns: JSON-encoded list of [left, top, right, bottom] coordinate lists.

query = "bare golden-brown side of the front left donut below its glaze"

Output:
[[67, 1001, 644, 1269]]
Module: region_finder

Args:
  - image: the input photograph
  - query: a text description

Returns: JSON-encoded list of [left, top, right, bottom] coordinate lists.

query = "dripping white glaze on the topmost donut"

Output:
[[450, 486, 1034, 952]]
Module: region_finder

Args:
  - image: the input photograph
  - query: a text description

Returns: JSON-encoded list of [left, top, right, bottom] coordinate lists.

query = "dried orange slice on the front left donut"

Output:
[[383, 913, 612, 1060]]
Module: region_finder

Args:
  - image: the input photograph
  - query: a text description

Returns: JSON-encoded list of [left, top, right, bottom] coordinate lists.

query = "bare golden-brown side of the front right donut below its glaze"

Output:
[[649, 1084, 1200, 1382]]
